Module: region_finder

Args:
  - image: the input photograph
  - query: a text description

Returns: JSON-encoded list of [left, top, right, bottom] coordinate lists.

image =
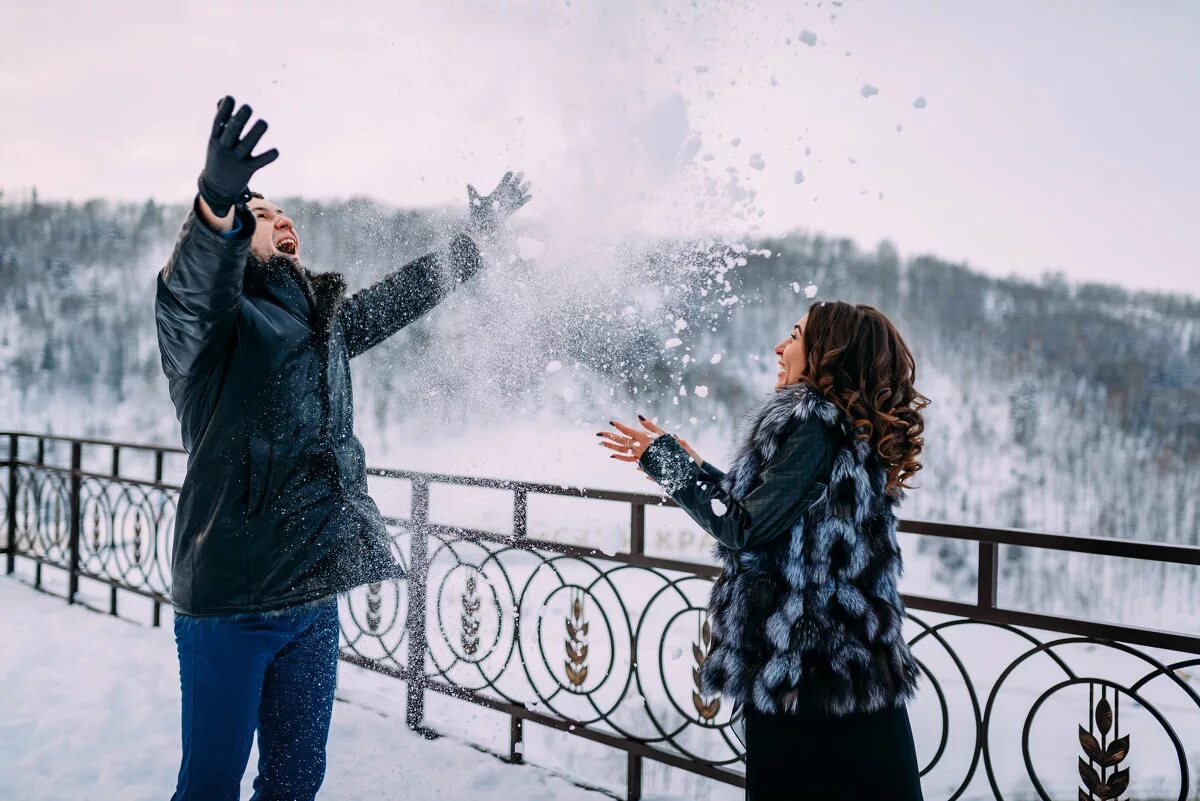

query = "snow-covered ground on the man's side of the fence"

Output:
[[0, 577, 664, 801]]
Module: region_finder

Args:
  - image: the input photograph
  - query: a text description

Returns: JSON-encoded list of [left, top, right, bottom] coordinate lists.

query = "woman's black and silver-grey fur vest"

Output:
[[702, 384, 918, 716]]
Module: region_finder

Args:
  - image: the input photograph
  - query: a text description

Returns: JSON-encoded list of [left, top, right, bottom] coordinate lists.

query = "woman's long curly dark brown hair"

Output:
[[800, 301, 930, 495]]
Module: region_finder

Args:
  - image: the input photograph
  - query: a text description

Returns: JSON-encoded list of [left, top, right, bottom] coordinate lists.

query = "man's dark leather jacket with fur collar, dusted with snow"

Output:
[[155, 205, 479, 615]]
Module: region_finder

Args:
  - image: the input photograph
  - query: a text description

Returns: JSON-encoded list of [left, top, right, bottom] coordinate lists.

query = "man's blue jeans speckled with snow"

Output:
[[172, 598, 338, 801]]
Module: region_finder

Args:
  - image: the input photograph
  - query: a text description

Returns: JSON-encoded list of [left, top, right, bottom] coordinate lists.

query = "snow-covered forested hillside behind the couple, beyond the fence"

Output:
[[0, 194, 1200, 558]]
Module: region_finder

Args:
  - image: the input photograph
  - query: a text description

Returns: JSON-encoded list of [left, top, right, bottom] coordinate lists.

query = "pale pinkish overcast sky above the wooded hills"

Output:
[[0, 0, 1200, 294]]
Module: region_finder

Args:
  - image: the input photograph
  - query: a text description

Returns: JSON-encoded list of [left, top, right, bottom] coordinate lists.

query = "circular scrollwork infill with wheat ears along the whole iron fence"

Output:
[[5, 453, 1200, 801]]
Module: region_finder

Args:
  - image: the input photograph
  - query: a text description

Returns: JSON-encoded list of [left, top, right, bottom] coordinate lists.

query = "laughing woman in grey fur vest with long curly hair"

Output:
[[598, 302, 929, 801]]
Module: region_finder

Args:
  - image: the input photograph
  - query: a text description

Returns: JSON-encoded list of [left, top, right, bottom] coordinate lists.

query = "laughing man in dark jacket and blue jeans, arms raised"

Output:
[[155, 97, 530, 801]]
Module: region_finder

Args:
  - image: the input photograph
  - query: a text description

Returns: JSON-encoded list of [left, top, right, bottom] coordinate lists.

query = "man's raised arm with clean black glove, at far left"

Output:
[[155, 97, 280, 381]]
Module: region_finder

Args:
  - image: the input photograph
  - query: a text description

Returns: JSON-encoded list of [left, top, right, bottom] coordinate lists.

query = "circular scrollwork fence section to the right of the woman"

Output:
[[910, 614, 1200, 801]]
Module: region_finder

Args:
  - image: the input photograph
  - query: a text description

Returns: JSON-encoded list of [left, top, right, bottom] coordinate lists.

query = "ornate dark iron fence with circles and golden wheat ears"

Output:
[[0, 433, 1200, 801]]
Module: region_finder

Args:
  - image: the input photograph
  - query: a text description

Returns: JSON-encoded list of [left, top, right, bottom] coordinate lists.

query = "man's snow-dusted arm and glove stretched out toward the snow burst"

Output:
[[340, 173, 533, 357]]
